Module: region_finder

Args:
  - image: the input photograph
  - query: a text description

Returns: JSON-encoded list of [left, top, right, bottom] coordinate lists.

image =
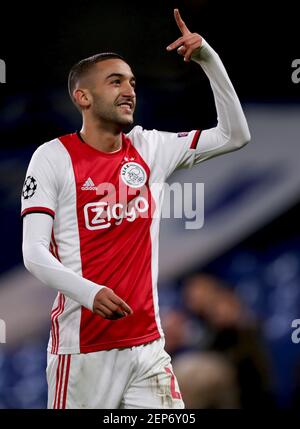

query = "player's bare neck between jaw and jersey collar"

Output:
[[80, 121, 122, 153]]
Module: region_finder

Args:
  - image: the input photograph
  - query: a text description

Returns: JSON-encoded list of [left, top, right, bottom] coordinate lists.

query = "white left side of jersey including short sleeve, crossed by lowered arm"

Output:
[[22, 139, 82, 353]]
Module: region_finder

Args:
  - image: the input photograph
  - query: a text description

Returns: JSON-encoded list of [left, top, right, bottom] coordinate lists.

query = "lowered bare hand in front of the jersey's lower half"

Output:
[[93, 287, 133, 320]]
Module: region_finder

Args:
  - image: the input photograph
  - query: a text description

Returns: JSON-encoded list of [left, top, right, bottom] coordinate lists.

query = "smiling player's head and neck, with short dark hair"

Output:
[[69, 53, 136, 147]]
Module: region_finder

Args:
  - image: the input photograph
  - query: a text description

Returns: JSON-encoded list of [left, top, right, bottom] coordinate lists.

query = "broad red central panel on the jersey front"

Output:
[[59, 134, 160, 353]]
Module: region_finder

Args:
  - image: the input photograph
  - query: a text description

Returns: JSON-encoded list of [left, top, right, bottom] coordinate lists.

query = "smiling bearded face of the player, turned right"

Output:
[[84, 58, 136, 127]]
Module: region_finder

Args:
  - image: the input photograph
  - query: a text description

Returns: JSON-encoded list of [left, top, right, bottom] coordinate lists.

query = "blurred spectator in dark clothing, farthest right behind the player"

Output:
[[183, 274, 275, 408]]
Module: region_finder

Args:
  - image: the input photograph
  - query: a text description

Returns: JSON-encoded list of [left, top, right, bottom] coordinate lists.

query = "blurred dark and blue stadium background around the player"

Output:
[[0, 0, 300, 408]]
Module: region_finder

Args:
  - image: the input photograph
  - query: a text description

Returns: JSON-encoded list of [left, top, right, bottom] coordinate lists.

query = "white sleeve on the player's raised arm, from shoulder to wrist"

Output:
[[132, 39, 250, 179]]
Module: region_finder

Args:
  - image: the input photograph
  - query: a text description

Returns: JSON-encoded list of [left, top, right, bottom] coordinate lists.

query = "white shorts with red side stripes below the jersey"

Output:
[[46, 338, 184, 409]]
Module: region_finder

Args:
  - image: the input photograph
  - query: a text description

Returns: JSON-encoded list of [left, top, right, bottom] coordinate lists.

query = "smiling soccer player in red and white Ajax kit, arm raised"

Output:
[[22, 9, 250, 409]]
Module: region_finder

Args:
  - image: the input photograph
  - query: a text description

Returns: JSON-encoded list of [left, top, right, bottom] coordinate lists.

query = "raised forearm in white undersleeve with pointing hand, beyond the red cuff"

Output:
[[167, 9, 250, 162]]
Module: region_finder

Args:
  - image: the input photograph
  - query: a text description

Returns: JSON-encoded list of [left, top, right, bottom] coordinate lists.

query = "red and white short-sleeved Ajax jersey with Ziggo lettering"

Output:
[[22, 126, 200, 354]]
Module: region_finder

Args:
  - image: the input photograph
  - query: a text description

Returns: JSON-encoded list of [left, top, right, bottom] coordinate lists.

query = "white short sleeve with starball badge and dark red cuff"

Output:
[[21, 142, 58, 218]]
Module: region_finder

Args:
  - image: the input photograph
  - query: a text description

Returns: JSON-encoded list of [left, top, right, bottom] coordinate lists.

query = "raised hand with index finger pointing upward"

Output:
[[167, 9, 202, 61]]
